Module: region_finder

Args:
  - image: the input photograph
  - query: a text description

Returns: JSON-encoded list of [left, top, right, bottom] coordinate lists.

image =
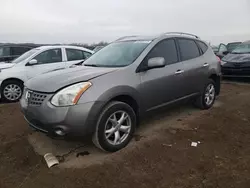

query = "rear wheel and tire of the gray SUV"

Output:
[[194, 79, 216, 110]]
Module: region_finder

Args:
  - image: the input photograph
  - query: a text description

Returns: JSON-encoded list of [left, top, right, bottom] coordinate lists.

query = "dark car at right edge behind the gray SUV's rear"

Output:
[[221, 41, 250, 77]]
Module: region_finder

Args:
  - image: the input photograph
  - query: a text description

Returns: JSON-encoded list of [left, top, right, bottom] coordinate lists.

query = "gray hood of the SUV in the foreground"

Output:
[[25, 66, 118, 93]]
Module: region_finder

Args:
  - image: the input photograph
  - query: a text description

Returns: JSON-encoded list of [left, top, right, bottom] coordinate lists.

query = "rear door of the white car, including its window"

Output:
[[65, 48, 92, 67]]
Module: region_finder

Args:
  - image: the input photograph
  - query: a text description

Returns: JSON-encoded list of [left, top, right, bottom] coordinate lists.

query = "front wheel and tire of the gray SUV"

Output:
[[92, 101, 136, 152]]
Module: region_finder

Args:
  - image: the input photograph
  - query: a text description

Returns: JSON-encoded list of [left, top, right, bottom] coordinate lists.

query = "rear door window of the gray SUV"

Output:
[[178, 39, 200, 61]]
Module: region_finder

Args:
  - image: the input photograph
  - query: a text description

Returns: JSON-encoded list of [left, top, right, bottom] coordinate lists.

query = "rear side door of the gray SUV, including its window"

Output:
[[177, 38, 209, 96]]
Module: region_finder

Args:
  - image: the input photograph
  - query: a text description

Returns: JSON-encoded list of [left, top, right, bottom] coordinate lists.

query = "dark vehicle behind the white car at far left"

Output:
[[0, 44, 38, 62]]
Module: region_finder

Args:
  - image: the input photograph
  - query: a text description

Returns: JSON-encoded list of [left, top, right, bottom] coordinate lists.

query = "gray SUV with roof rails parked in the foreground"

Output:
[[20, 33, 221, 152]]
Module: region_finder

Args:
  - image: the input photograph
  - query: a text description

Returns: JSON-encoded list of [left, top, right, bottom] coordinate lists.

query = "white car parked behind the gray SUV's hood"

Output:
[[0, 46, 93, 102]]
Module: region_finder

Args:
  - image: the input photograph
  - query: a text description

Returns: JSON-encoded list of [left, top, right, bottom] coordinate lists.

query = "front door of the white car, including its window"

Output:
[[26, 48, 65, 79]]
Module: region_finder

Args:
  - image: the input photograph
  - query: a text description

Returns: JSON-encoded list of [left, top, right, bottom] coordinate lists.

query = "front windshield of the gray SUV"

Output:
[[84, 41, 151, 67]]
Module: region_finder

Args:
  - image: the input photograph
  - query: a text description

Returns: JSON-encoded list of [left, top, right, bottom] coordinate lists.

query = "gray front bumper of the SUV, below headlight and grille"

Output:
[[20, 96, 103, 136]]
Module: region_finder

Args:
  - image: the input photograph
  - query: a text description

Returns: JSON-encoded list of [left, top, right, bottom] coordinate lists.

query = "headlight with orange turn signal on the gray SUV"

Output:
[[51, 82, 92, 106]]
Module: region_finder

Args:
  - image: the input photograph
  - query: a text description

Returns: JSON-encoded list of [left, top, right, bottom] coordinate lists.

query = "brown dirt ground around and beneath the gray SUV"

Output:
[[0, 83, 250, 188]]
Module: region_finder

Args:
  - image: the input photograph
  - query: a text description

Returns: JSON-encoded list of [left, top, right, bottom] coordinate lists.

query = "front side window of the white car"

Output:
[[34, 49, 62, 64]]
